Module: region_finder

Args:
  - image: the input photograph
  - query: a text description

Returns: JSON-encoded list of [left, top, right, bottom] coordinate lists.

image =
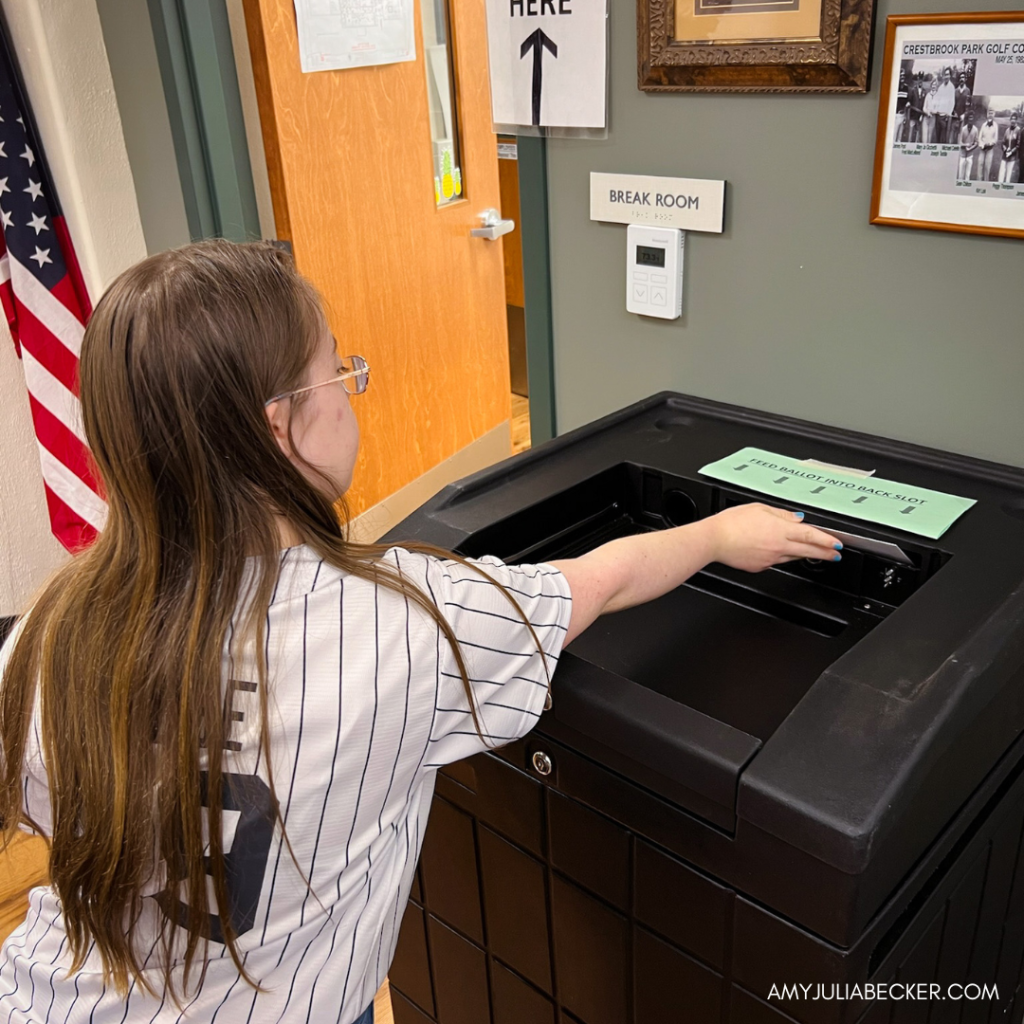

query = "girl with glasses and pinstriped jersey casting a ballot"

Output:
[[0, 242, 838, 1024]]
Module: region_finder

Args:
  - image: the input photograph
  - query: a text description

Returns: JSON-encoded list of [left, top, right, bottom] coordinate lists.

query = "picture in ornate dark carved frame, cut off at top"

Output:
[[637, 0, 874, 92]]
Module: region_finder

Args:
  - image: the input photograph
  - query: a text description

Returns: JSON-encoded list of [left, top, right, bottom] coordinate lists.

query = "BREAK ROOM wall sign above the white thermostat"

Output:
[[590, 171, 725, 233]]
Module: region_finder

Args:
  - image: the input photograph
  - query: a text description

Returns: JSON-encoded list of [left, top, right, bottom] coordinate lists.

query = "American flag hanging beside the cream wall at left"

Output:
[[0, 25, 106, 552]]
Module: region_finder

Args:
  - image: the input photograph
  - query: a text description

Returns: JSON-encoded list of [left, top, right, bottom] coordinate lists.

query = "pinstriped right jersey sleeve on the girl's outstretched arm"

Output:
[[424, 556, 572, 768]]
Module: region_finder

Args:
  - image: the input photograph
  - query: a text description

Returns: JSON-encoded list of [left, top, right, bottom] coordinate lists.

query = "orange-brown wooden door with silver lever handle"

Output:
[[245, 0, 510, 515]]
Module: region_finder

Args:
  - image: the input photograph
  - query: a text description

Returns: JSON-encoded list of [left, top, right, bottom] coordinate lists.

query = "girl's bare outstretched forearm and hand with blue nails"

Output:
[[551, 504, 842, 643]]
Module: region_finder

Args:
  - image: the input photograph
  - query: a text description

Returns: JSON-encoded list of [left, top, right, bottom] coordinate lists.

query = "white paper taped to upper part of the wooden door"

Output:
[[295, 0, 416, 71]]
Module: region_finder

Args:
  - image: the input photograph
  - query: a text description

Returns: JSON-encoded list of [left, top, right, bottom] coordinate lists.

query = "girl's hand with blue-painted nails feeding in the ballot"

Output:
[[707, 503, 843, 572]]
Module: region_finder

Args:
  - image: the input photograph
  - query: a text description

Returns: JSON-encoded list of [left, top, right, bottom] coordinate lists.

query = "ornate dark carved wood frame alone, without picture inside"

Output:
[[637, 0, 874, 92]]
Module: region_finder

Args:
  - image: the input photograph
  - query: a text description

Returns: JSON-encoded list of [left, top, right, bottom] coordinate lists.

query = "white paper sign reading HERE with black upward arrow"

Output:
[[487, 0, 607, 128]]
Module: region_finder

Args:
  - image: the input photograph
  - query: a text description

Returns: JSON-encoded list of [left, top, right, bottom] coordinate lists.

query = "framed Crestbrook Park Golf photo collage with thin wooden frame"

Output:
[[870, 11, 1024, 239]]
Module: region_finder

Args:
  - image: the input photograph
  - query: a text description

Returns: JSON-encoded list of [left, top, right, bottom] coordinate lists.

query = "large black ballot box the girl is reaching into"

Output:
[[380, 394, 1024, 1024]]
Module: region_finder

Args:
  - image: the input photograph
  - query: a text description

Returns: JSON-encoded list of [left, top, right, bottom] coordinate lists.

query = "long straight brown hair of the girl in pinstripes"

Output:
[[0, 242, 543, 999]]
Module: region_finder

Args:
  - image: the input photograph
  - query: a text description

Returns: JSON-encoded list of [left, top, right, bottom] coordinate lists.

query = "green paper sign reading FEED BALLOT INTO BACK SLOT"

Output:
[[700, 449, 976, 541]]
